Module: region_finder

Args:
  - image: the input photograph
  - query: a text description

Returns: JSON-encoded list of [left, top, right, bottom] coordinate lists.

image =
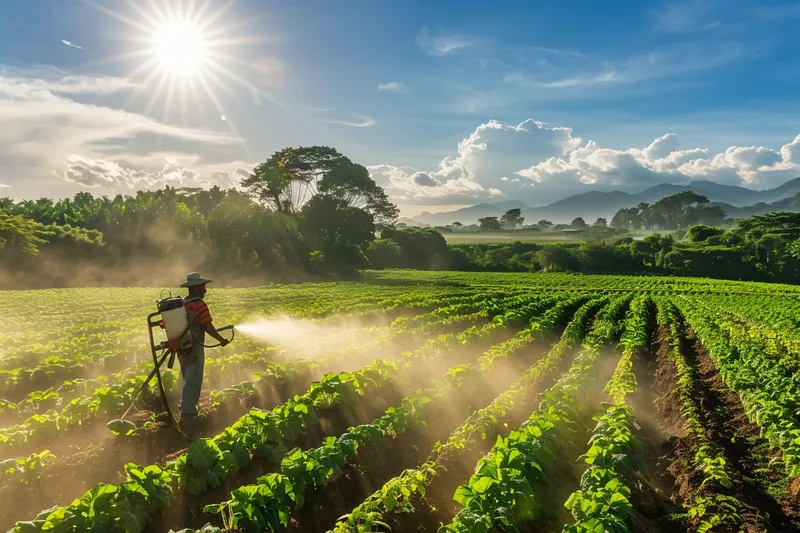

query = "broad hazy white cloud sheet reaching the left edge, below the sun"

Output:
[[0, 67, 241, 195]]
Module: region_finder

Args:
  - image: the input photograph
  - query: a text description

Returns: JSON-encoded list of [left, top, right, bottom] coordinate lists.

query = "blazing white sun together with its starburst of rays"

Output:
[[82, 0, 272, 131]]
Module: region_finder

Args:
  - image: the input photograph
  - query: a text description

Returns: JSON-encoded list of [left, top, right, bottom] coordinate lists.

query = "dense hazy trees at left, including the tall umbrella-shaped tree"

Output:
[[0, 146, 432, 287]]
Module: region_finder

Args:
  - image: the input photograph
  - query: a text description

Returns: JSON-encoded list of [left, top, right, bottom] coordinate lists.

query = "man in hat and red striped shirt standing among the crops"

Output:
[[178, 272, 229, 425]]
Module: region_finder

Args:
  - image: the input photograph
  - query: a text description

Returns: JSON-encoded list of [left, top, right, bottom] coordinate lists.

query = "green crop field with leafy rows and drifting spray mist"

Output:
[[0, 271, 800, 533]]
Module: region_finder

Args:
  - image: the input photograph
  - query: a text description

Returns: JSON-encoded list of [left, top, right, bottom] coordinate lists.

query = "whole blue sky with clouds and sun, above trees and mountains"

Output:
[[0, 0, 800, 214]]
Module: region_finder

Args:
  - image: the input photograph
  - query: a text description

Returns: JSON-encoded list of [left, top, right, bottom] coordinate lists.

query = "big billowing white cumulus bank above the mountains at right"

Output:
[[369, 120, 800, 205]]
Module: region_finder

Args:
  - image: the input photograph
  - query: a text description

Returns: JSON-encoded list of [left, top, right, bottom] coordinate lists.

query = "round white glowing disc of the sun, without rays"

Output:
[[153, 20, 208, 76]]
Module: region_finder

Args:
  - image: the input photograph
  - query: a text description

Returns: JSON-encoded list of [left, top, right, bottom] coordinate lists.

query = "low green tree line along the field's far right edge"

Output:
[[449, 213, 800, 283]]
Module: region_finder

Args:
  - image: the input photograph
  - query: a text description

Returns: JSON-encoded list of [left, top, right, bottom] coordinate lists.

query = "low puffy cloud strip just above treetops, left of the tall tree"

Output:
[[55, 154, 250, 193]]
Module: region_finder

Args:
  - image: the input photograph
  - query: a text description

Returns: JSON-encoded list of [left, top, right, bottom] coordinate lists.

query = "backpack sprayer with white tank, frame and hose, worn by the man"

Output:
[[108, 292, 236, 438]]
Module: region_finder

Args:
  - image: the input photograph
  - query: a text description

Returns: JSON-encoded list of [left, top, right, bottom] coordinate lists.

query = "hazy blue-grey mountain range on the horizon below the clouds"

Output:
[[405, 178, 800, 226]]
